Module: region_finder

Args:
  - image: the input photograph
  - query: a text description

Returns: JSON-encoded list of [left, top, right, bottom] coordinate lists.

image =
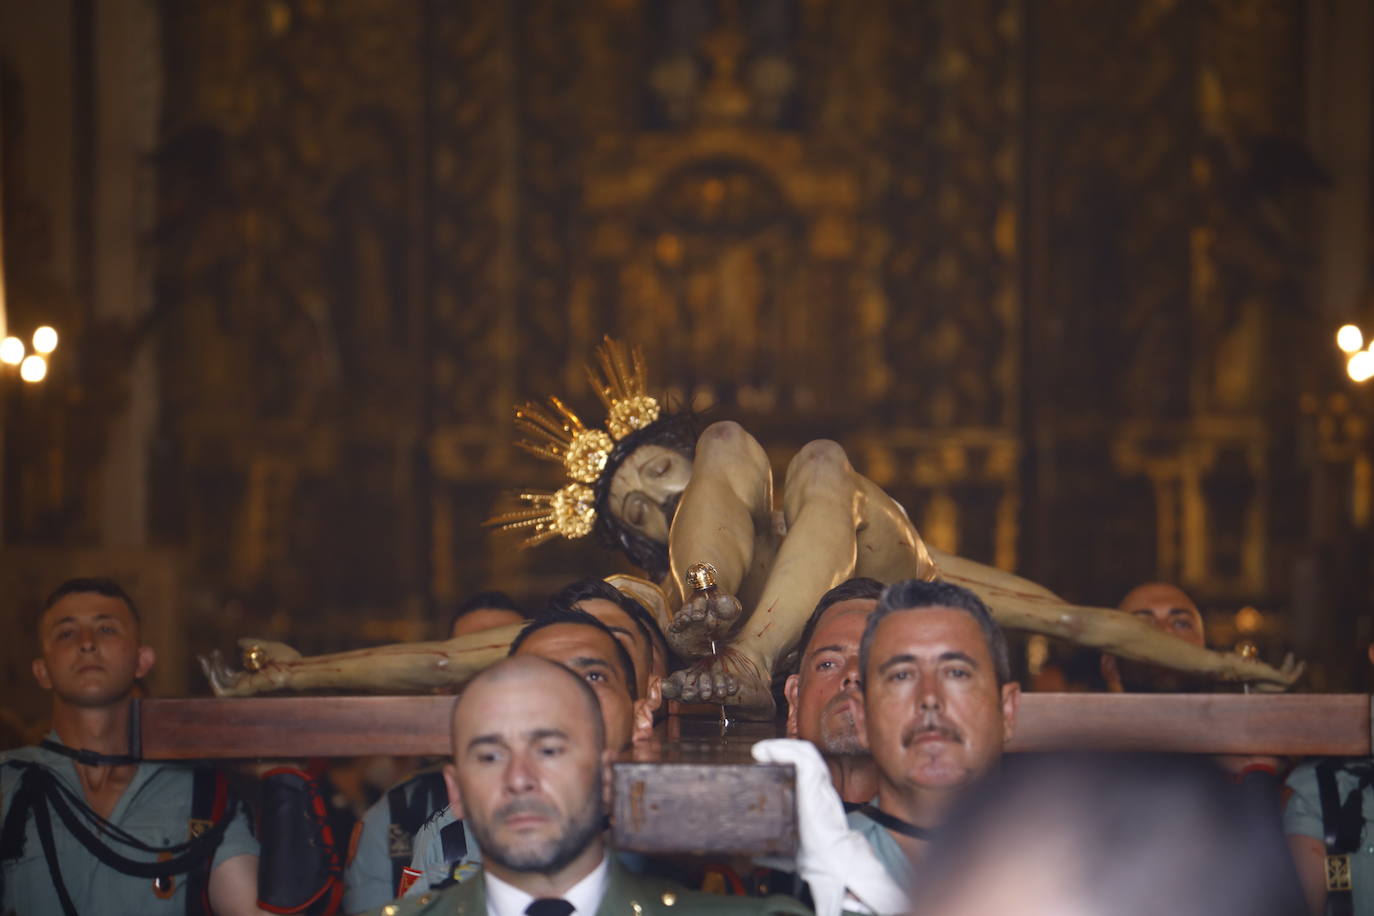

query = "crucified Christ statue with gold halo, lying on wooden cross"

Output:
[[206, 341, 1303, 711]]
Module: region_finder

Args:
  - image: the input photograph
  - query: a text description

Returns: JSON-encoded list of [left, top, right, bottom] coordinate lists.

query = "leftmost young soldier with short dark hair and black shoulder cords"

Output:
[[0, 580, 262, 916]]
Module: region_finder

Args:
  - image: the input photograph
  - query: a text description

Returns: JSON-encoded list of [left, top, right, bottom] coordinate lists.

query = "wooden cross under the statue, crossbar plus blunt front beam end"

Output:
[[133, 694, 1371, 856]]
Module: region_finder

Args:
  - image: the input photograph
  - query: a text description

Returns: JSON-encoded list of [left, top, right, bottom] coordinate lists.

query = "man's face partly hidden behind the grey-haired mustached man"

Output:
[[783, 578, 882, 803]]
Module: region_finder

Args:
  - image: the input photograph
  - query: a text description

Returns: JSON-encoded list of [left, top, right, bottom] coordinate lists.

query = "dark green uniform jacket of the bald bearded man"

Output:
[[374, 857, 811, 916]]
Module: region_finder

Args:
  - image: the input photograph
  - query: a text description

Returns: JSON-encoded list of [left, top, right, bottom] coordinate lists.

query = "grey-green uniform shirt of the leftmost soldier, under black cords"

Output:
[[0, 733, 258, 916]]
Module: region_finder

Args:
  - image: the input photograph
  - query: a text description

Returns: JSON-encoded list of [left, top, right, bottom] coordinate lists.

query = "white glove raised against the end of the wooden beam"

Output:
[[753, 737, 911, 916]]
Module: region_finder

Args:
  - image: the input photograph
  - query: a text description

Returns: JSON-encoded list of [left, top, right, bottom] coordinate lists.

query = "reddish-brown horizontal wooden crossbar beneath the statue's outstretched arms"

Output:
[[135, 694, 1371, 762]]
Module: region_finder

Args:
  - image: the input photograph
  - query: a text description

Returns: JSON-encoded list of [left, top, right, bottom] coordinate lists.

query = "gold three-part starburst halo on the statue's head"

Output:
[[484, 336, 662, 547]]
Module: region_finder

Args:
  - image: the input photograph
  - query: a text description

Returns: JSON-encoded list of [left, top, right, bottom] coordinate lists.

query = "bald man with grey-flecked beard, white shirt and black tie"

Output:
[[379, 655, 805, 916]]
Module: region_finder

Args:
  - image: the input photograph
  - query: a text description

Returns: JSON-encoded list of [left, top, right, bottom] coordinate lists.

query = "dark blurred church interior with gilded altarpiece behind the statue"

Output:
[[8, 0, 1374, 912]]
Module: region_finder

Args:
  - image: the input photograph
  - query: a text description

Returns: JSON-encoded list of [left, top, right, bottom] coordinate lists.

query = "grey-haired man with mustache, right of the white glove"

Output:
[[849, 580, 1021, 887]]
